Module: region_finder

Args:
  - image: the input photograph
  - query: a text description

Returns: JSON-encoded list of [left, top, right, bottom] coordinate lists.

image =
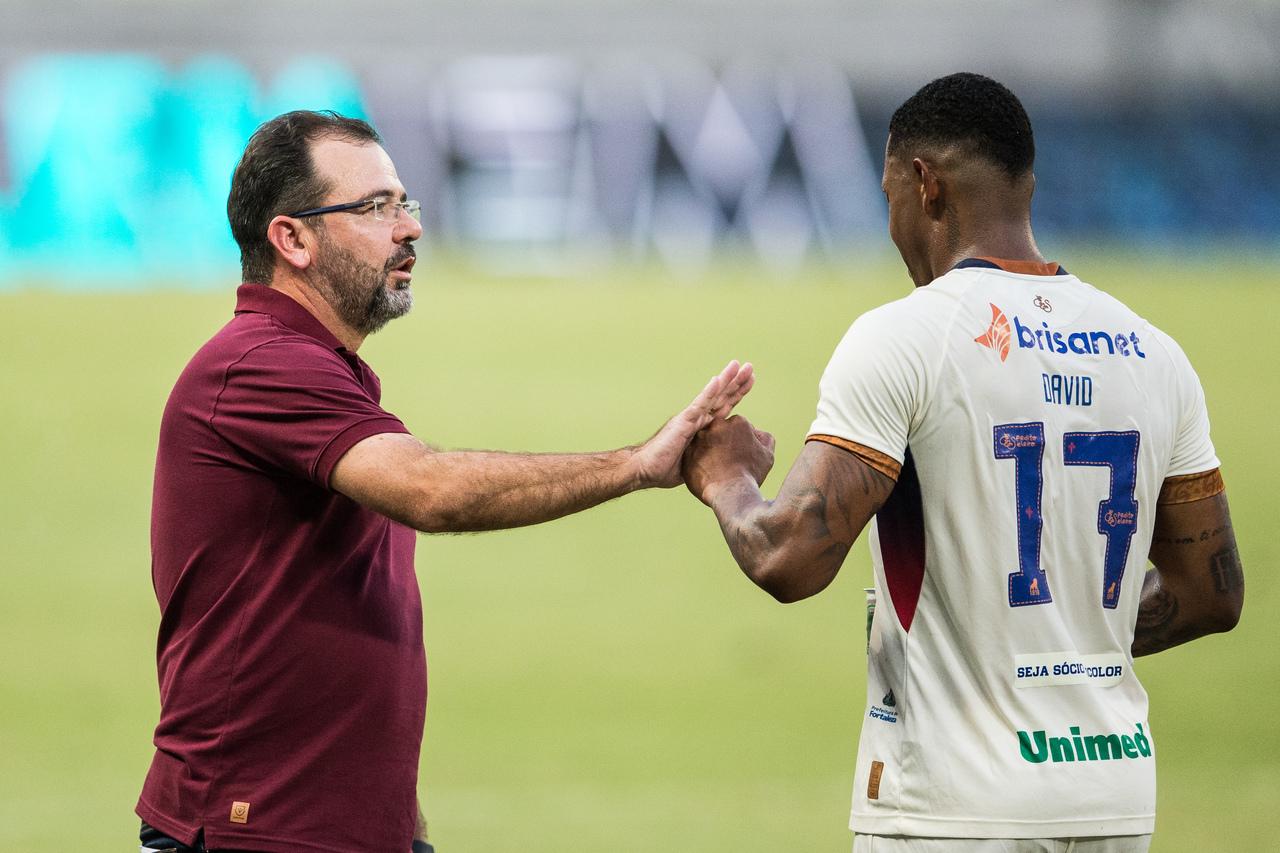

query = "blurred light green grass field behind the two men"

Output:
[[0, 257, 1280, 853]]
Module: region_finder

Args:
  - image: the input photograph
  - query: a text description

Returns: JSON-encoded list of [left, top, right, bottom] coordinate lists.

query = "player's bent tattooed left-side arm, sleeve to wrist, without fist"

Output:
[[714, 442, 893, 602]]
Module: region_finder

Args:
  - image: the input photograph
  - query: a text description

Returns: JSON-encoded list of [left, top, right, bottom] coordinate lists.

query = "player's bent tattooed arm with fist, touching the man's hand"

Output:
[[685, 418, 893, 602]]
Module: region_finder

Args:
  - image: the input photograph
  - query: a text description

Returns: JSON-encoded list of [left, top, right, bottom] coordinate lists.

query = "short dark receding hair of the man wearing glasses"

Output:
[[227, 110, 381, 284]]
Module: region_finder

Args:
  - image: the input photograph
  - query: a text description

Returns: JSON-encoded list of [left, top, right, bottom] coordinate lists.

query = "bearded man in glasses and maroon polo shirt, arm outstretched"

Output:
[[137, 111, 753, 853]]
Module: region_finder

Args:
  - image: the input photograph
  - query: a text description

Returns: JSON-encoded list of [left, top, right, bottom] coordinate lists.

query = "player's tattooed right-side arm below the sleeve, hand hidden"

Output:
[[1133, 473, 1244, 657]]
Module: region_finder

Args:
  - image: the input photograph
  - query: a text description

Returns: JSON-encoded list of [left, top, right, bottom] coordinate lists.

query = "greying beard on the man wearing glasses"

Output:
[[311, 241, 413, 336]]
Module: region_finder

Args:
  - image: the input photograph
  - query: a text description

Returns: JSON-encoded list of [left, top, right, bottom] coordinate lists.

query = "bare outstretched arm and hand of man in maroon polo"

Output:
[[329, 361, 754, 533]]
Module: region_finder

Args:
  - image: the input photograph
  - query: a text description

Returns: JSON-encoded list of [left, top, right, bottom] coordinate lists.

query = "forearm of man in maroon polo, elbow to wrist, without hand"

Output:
[[404, 448, 645, 533]]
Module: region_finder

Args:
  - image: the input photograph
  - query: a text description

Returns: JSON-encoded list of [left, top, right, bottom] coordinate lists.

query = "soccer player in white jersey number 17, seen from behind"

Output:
[[685, 74, 1244, 853]]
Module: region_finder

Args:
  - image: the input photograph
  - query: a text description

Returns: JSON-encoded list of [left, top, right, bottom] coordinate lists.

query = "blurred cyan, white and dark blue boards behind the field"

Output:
[[0, 53, 1280, 287]]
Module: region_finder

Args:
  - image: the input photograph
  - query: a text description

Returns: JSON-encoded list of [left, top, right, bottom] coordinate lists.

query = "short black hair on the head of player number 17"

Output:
[[888, 72, 1036, 178]]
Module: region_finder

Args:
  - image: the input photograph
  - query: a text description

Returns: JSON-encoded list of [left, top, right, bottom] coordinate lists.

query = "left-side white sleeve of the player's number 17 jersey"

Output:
[[809, 304, 927, 465]]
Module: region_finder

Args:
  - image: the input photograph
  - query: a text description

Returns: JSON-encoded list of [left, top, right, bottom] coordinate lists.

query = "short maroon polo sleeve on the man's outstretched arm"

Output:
[[209, 338, 408, 488]]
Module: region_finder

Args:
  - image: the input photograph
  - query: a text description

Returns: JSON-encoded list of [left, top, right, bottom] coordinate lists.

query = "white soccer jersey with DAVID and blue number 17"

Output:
[[810, 260, 1219, 838]]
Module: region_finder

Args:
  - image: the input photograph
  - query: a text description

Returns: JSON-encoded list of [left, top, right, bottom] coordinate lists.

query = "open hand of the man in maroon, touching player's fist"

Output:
[[634, 361, 747, 489]]
